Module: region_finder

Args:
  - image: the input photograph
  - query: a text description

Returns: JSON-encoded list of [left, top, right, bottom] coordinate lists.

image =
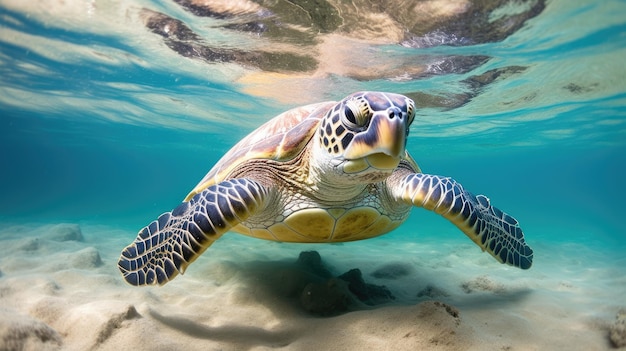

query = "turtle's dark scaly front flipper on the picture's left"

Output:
[[118, 179, 268, 285]]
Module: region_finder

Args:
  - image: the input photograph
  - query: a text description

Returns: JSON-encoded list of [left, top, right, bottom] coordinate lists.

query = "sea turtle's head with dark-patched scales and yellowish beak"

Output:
[[319, 92, 415, 175]]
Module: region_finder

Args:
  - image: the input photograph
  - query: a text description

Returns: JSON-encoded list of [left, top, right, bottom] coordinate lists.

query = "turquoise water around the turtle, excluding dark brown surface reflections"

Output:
[[0, 0, 626, 257]]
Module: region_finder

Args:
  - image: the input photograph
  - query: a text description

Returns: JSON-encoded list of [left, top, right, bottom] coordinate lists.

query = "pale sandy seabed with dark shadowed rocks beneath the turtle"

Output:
[[0, 224, 626, 350]]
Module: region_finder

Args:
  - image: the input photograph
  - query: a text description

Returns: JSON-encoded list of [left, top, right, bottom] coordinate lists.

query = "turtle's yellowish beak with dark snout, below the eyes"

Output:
[[343, 108, 407, 161]]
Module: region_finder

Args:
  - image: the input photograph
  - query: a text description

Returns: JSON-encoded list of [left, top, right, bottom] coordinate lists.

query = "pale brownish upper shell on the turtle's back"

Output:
[[185, 101, 336, 201]]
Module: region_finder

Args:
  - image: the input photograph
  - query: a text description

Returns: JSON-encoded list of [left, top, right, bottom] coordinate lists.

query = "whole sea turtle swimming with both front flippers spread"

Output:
[[118, 92, 533, 285]]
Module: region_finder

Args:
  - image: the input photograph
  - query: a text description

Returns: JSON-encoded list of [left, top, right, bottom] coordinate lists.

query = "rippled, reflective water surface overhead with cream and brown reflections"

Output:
[[0, 0, 626, 150]]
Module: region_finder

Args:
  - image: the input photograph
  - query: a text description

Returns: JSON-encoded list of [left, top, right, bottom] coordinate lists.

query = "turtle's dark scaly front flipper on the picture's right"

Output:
[[394, 173, 533, 269]]
